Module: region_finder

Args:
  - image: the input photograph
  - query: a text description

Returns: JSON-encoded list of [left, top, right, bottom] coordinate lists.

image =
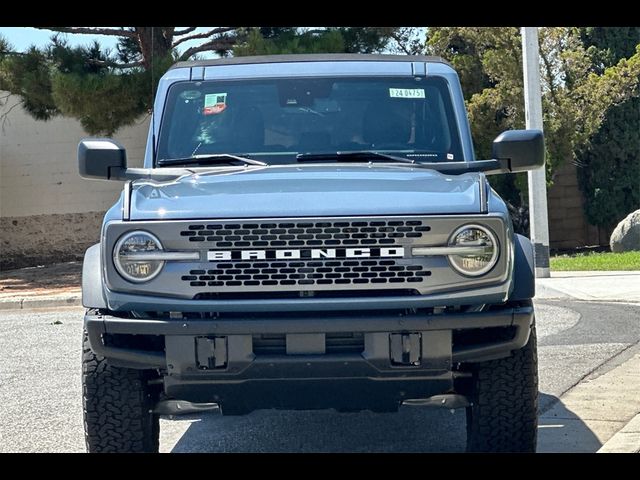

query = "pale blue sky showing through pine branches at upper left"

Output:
[[0, 27, 222, 58]]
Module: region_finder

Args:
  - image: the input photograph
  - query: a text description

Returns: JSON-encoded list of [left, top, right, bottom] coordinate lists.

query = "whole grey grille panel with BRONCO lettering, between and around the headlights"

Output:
[[104, 215, 510, 300]]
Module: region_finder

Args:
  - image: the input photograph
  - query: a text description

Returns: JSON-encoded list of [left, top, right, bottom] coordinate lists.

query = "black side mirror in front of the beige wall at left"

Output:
[[78, 138, 127, 180]]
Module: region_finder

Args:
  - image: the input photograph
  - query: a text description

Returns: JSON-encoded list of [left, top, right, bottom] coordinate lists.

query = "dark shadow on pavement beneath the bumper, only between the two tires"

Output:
[[161, 407, 465, 452]]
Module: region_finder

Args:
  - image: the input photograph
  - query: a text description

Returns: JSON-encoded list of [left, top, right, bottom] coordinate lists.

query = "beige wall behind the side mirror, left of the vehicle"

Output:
[[0, 93, 149, 269]]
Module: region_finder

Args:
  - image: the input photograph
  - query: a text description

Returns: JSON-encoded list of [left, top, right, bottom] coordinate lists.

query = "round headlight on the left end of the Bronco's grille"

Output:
[[113, 230, 164, 283]]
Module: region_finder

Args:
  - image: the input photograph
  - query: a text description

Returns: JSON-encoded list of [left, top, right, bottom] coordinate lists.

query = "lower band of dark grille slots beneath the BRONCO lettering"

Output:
[[181, 259, 431, 287]]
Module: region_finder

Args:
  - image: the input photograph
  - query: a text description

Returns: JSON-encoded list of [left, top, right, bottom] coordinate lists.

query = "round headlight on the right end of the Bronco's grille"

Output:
[[449, 225, 498, 277]]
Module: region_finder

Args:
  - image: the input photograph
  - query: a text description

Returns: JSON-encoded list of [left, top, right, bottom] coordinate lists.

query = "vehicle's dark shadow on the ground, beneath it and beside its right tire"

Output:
[[161, 392, 601, 452]]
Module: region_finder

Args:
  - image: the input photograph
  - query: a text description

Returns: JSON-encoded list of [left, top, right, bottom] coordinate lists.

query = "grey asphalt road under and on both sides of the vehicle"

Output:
[[0, 301, 640, 452]]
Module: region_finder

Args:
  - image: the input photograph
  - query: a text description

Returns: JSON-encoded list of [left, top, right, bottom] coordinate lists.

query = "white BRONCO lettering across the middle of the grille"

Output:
[[207, 247, 404, 262]]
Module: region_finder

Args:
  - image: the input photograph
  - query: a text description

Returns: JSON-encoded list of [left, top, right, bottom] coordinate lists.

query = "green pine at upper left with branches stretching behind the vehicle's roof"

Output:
[[0, 27, 417, 135]]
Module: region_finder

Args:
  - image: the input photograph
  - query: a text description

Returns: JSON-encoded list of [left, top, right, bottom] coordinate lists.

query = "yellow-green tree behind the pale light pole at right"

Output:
[[427, 27, 640, 217]]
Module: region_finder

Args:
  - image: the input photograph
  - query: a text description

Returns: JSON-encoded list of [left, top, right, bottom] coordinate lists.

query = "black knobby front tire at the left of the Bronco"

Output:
[[82, 332, 160, 453]]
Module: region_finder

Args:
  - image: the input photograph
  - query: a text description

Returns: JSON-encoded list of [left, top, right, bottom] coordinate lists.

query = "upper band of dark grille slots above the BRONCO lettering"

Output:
[[180, 220, 431, 248]]
